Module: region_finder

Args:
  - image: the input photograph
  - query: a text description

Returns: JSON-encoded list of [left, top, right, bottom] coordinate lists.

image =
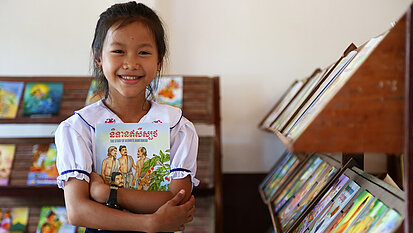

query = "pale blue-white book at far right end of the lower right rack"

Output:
[[368, 209, 403, 233]]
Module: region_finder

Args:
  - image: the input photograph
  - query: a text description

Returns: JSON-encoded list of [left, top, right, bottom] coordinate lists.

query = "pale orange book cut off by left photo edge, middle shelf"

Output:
[[0, 144, 16, 186]]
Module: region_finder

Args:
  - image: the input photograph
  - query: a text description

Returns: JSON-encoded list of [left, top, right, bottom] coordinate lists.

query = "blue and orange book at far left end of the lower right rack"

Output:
[[260, 152, 300, 200]]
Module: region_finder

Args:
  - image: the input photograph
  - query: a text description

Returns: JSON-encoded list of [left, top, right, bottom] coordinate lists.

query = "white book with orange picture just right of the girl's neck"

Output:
[[155, 76, 184, 108]]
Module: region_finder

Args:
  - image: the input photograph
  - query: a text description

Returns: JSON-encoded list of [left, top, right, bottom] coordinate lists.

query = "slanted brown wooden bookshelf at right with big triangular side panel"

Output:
[[259, 6, 413, 232]]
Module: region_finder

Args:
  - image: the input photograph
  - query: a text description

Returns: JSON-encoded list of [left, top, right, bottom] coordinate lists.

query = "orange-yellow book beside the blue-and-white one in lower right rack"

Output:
[[328, 190, 373, 233]]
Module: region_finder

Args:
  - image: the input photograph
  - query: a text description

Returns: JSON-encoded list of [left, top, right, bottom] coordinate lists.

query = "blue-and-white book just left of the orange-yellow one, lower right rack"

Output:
[[309, 181, 360, 233]]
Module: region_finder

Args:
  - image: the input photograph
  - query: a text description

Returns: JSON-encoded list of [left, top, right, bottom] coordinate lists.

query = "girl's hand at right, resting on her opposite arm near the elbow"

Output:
[[149, 189, 195, 232]]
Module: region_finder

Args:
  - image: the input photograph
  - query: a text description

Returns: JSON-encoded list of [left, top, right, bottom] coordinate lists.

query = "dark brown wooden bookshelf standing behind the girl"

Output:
[[0, 76, 222, 233]]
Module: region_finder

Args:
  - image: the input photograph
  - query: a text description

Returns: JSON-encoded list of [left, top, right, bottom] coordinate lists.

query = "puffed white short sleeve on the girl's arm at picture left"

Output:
[[55, 119, 93, 188]]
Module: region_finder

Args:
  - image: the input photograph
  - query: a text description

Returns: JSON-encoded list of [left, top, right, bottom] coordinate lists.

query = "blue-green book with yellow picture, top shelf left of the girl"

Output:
[[23, 82, 63, 116]]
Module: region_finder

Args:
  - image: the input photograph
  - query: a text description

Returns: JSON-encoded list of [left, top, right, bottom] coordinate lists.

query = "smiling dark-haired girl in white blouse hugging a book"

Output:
[[55, 2, 199, 232]]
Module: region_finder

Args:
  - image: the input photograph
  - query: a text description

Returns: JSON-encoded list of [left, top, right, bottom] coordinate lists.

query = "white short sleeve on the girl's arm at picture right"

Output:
[[170, 117, 199, 186]]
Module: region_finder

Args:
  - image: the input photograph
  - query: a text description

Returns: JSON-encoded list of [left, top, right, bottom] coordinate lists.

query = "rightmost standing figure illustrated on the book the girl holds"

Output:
[[132, 147, 151, 190]]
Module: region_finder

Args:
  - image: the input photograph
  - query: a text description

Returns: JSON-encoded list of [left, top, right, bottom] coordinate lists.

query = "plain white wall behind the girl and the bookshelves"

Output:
[[0, 0, 412, 173]]
